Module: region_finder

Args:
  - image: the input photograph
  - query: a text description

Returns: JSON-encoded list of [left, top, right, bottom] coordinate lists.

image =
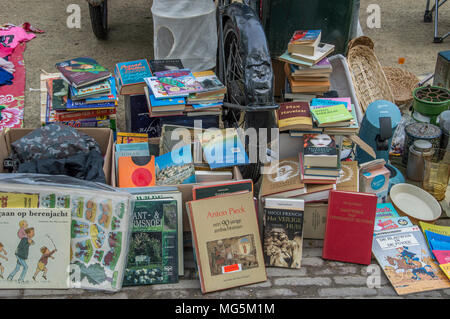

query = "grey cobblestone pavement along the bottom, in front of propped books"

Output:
[[0, 240, 450, 299]]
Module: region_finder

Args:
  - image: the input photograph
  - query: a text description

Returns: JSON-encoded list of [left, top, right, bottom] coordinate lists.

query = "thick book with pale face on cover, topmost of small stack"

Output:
[[303, 134, 338, 167]]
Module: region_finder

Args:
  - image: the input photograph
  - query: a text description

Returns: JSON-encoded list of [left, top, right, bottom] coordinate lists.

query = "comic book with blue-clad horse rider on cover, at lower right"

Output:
[[372, 225, 450, 295]]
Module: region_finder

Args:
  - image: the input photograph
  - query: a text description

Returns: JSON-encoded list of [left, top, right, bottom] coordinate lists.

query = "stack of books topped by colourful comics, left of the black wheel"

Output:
[[144, 59, 226, 117]]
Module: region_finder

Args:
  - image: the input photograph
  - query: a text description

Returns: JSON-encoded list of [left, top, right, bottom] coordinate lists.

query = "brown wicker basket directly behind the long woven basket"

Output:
[[383, 66, 419, 106]]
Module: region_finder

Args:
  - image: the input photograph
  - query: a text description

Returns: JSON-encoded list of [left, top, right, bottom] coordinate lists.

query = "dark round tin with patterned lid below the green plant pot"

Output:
[[402, 123, 442, 164]]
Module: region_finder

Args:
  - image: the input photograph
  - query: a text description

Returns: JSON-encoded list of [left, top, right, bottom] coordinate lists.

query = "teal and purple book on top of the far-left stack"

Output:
[[56, 57, 111, 88]]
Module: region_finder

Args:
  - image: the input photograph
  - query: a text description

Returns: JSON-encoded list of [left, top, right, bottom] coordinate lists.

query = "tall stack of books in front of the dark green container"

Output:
[[278, 30, 334, 99]]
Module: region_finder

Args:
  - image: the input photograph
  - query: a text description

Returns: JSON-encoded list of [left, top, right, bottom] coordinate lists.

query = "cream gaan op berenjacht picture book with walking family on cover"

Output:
[[0, 209, 71, 289]]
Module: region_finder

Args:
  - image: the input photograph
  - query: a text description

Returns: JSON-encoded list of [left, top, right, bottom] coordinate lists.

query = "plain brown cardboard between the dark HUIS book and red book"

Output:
[[303, 203, 328, 239]]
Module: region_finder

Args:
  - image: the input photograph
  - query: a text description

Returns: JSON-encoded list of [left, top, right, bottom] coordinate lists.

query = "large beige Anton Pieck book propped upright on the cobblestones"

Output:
[[186, 192, 267, 293]]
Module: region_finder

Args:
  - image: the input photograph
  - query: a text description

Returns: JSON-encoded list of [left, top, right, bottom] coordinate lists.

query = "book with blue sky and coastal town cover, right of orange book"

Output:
[[155, 144, 195, 185]]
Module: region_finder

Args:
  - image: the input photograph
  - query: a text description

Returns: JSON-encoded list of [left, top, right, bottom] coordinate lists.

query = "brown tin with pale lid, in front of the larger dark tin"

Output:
[[406, 140, 433, 182]]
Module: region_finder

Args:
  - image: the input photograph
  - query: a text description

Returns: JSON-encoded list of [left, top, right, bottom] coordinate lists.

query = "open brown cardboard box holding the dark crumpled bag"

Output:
[[0, 128, 114, 186]]
